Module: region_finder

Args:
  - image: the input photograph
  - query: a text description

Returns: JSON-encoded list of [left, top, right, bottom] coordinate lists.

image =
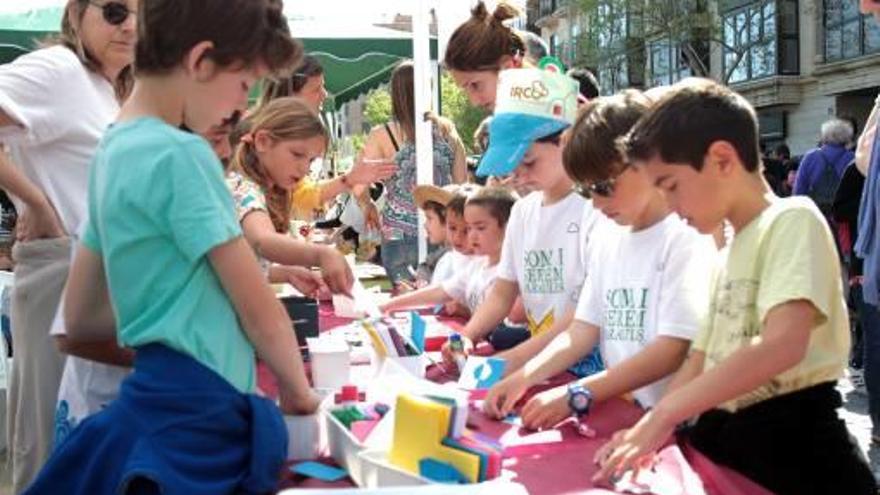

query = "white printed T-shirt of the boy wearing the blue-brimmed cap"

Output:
[[498, 191, 601, 335]]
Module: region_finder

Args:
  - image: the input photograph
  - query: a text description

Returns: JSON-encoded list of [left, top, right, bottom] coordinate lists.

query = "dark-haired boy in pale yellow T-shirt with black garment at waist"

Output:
[[596, 81, 877, 495]]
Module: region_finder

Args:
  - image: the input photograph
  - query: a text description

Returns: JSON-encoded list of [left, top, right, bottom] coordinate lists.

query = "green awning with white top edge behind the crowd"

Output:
[[0, 7, 437, 108]]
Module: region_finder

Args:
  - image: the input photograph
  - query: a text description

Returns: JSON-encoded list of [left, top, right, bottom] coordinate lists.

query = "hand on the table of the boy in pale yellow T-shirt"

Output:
[[593, 410, 675, 483]]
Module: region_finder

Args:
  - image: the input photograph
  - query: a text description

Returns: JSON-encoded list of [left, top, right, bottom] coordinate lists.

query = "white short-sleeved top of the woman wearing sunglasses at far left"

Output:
[[0, 46, 119, 235]]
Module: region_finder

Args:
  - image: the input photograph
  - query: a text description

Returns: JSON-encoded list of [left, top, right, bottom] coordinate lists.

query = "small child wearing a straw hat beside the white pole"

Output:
[[413, 184, 458, 287]]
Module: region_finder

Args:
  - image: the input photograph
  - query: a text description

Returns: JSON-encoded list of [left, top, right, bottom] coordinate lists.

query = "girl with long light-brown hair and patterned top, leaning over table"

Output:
[[226, 97, 354, 298]]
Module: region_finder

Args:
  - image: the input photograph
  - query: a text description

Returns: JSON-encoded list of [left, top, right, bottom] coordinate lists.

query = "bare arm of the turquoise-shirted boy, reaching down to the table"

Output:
[[208, 237, 320, 414]]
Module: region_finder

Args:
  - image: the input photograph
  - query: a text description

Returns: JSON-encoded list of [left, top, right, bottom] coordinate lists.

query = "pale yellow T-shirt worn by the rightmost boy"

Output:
[[693, 197, 850, 412]]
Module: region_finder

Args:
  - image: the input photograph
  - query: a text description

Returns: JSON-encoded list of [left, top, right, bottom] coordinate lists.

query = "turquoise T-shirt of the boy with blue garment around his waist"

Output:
[[82, 117, 255, 392]]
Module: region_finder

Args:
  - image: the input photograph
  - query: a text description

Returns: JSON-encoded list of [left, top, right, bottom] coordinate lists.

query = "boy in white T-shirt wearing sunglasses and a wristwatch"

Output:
[[485, 90, 717, 429]]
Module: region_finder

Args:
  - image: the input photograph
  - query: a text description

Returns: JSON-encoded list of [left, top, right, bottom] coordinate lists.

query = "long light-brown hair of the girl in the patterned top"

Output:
[[231, 97, 329, 233]]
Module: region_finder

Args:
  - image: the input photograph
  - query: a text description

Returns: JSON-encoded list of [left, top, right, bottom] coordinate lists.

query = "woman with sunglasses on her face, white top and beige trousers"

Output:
[[0, 0, 138, 493]]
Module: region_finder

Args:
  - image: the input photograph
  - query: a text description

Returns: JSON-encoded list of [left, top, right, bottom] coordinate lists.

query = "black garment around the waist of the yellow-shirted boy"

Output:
[[683, 382, 877, 495]]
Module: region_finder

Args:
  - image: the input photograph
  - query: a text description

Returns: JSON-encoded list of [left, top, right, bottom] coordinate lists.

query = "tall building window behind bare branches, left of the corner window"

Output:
[[722, 0, 779, 83]]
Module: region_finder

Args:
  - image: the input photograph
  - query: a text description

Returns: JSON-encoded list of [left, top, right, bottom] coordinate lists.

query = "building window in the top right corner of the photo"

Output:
[[823, 0, 880, 62]]
